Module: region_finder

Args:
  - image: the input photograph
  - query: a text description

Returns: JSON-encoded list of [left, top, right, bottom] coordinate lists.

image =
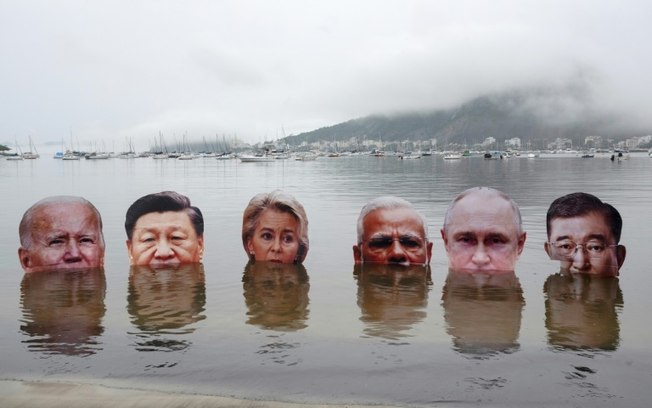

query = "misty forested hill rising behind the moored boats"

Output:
[[283, 91, 650, 147]]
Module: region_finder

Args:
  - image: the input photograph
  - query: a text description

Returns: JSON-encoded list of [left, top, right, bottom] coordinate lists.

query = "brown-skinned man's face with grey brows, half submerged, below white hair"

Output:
[[353, 208, 432, 265]]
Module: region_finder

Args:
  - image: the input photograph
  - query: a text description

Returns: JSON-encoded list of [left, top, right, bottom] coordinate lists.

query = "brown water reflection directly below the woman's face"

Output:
[[242, 261, 310, 331]]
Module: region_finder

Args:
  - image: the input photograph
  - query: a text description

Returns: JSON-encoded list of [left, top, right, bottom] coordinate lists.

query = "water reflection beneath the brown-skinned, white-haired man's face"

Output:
[[353, 263, 432, 340]]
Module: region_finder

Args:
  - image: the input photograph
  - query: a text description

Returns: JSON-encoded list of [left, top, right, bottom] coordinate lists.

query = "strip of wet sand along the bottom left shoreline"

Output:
[[0, 381, 402, 408]]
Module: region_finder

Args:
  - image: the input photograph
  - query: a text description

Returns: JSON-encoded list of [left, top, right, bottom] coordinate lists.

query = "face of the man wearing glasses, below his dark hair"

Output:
[[545, 213, 625, 276]]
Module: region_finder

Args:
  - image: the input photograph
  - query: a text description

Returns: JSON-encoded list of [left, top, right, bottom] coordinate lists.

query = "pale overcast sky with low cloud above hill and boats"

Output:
[[0, 0, 652, 150]]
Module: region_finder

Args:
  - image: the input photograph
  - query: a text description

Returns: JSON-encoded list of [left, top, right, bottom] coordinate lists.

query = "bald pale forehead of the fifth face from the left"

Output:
[[447, 193, 518, 231]]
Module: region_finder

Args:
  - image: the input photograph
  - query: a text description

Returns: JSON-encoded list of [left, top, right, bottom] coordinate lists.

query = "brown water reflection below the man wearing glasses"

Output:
[[543, 272, 623, 350]]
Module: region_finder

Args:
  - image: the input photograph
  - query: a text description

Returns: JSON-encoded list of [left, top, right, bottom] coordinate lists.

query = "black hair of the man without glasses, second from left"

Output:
[[125, 191, 204, 239]]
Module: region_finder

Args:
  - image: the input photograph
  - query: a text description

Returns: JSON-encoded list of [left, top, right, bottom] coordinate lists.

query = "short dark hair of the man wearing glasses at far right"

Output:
[[546, 192, 623, 243]]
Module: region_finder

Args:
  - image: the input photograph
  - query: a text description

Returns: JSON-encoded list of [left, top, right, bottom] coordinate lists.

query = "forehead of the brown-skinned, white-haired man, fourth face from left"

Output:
[[362, 208, 425, 236]]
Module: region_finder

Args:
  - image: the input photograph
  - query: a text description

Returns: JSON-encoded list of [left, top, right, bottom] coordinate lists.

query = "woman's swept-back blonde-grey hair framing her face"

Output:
[[242, 190, 310, 263]]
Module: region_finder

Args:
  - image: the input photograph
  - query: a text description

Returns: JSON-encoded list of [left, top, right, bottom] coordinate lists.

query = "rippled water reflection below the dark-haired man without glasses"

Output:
[[127, 263, 206, 351]]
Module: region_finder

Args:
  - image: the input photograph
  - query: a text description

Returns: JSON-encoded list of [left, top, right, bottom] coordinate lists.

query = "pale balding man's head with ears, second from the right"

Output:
[[441, 193, 525, 272]]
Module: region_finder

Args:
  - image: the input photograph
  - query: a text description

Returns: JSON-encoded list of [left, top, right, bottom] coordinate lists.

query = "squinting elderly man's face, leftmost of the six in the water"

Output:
[[18, 203, 104, 272]]
